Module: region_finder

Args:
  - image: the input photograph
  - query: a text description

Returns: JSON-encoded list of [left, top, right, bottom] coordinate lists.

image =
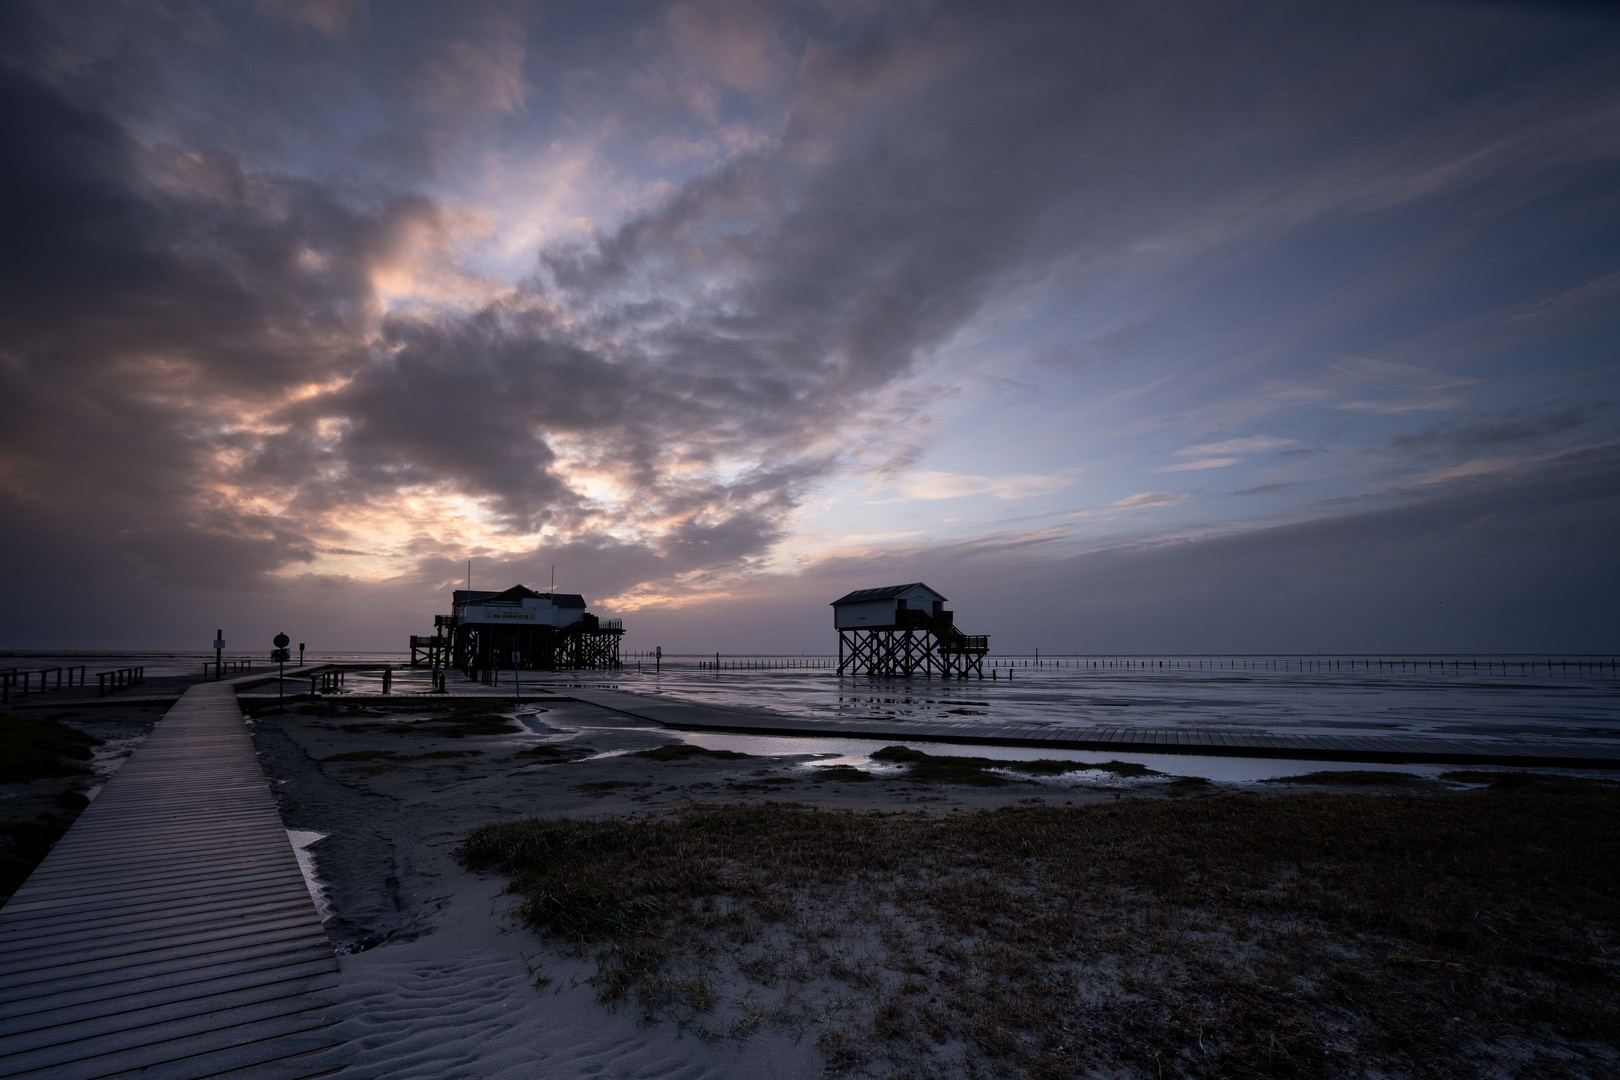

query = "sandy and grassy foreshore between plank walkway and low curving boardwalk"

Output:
[[254, 701, 1620, 1077]]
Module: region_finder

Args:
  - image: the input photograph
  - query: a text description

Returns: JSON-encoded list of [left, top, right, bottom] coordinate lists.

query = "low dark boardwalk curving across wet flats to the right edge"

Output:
[[549, 683, 1620, 769]]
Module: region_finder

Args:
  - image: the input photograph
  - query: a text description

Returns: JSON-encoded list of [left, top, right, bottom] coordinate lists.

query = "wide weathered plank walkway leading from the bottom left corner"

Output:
[[0, 675, 337, 1080]]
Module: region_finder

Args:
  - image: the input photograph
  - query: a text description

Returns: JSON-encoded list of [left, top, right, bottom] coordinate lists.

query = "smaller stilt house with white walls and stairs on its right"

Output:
[[833, 581, 990, 678]]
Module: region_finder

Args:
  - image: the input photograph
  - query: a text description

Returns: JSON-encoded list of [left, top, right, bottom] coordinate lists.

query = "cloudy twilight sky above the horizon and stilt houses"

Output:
[[0, 0, 1620, 653]]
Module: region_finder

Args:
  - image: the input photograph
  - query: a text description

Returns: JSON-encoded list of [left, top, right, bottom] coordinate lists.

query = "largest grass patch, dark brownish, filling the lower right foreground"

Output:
[[460, 785, 1620, 1080]]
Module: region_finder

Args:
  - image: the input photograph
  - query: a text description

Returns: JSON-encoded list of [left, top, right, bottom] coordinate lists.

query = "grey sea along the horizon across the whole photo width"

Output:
[[0, 651, 1620, 751]]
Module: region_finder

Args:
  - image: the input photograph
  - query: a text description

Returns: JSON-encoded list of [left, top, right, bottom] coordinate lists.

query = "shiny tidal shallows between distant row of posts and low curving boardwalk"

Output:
[[580, 657, 1620, 738]]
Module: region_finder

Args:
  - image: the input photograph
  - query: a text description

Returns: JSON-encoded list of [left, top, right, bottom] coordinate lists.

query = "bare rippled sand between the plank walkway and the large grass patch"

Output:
[[254, 701, 1192, 1077]]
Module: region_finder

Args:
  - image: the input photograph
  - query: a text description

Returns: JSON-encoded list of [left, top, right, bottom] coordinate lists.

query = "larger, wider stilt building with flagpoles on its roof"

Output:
[[410, 585, 624, 675]]
